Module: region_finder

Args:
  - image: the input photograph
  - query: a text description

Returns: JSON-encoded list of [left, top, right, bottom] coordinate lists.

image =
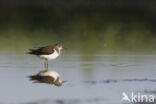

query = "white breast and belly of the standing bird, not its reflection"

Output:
[[39, 49, 59, 60]]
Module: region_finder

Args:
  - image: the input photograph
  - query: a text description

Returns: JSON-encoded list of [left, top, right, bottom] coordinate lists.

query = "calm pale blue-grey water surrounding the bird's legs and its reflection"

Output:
[[0, 51, 156, 104]]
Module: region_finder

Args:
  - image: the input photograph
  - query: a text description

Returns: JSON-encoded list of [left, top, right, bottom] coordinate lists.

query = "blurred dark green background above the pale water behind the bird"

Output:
[[0, 0, 156, 53]]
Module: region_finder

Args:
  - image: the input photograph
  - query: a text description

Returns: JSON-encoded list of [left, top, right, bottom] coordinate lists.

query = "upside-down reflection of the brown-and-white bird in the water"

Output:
[[29, 70, 66, 86]]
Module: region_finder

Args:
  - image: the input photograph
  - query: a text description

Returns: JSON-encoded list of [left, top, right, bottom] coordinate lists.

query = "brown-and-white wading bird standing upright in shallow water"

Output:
[[28, 43, 63, 71]]
